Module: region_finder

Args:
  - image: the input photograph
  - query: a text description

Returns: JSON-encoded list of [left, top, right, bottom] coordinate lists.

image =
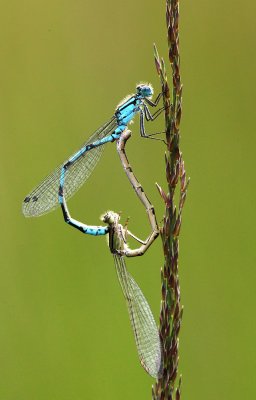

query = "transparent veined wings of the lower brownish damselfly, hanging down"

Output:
[[114, 255, 162, 378]]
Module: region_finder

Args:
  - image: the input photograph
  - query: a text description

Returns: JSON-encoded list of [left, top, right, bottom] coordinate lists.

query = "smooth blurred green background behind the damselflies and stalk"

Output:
[[0, 0, 256, 400]]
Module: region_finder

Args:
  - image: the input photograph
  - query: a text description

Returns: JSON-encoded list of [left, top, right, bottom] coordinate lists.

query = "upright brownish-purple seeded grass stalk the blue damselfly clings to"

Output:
[[152, 0, 189, 400]]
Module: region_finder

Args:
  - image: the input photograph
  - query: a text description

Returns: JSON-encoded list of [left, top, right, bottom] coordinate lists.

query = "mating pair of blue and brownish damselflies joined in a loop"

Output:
[[23, 84, 163, 377]]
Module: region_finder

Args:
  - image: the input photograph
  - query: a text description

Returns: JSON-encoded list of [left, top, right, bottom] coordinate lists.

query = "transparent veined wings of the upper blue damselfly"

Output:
[[22, 117, 117, 217]]
